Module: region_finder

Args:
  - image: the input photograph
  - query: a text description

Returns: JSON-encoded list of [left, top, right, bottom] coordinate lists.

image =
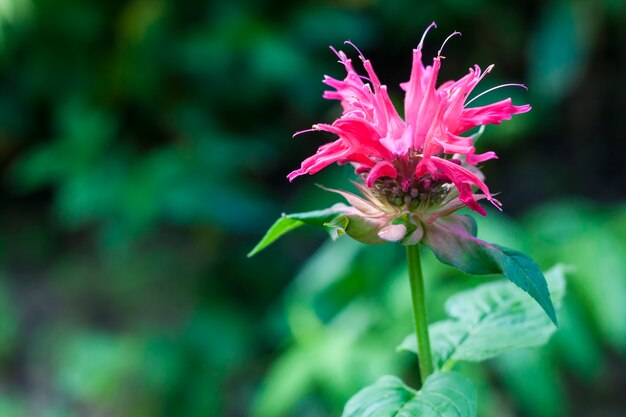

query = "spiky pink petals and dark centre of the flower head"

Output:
[[288, 23, 530, 218]]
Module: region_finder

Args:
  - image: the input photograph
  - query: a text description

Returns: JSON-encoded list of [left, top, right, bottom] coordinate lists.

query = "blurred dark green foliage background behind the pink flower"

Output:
[[0, 0, 626, 417]]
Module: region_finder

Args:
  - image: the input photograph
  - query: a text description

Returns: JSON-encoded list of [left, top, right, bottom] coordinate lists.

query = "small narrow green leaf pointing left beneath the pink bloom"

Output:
[[248, 204, 346, 258]]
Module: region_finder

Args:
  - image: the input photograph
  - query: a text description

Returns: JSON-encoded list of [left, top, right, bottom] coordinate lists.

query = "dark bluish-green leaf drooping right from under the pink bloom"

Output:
[[423, 215, 557, 324]]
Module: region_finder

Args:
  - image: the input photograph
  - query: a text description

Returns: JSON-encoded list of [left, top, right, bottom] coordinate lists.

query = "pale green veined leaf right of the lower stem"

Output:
[[399, 265, 565, 370]]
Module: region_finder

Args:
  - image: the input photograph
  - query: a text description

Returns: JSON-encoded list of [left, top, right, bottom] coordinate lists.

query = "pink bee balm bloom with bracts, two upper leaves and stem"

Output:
[[248, 23, 557, 330]]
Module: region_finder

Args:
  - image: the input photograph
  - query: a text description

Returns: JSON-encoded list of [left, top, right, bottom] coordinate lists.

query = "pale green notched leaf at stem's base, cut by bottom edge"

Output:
[[342, 372, 476, 417]]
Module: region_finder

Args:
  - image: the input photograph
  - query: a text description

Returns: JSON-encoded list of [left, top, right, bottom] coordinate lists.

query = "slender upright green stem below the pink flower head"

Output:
[[406, 245, 433, 384]]
